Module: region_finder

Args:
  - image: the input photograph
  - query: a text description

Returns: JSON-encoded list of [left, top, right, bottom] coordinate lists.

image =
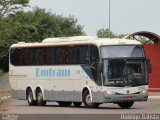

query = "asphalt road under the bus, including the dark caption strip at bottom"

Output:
[[0, 98, 160, 120]]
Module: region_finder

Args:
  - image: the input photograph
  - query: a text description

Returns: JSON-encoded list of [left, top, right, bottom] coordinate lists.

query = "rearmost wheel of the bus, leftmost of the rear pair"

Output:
[[27, 89, 37, 106]]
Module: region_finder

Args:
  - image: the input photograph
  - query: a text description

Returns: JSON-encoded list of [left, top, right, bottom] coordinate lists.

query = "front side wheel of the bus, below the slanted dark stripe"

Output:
[[82, 91, 100, 108]]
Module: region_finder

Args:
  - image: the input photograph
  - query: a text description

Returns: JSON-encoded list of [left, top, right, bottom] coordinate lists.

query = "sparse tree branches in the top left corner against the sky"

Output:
[[0, 0, 29, 19]]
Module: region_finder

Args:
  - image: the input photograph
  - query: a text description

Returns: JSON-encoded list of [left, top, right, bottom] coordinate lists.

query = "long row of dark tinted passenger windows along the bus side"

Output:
[[10, 45, 99, 65]]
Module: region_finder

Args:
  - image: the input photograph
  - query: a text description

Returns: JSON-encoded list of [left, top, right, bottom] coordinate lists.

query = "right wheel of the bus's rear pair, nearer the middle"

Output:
[[36, 90, 46, 106]]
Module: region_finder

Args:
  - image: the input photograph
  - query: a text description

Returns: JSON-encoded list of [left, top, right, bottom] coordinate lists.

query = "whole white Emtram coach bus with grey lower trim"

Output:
[[9, 36, 151, 108]]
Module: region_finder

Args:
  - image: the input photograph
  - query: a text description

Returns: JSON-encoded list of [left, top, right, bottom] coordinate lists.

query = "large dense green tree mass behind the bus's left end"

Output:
[[0, 7, 84, 70]]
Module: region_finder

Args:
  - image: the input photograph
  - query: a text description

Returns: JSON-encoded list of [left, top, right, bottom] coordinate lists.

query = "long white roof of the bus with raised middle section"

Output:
[[11, 36, 141, 47]]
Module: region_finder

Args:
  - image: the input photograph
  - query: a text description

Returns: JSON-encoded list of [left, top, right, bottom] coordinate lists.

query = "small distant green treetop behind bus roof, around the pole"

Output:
[[97, 28, 125, 38]]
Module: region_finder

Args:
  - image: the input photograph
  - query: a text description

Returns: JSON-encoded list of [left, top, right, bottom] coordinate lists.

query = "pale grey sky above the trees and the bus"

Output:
[[26, 0, 160, 36]]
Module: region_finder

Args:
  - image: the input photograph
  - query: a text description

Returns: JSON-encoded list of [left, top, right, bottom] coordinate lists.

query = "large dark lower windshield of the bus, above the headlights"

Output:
[[104, 59, 147, 87]]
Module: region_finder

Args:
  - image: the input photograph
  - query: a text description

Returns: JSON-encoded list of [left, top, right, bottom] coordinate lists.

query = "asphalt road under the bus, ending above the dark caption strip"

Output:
[[0, 98, 160, 114]]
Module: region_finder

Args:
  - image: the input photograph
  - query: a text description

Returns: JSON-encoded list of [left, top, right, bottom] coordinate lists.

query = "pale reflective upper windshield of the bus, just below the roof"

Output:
[[101, 45, 145, 58]]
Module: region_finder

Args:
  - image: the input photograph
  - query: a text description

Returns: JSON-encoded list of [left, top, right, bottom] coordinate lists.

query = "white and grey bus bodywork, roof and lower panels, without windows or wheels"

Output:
[[9, 37, 148, 103]]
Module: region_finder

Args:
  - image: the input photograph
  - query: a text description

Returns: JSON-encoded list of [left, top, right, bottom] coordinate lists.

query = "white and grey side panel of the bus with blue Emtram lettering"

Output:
[[9, 65, 101, 101]]
